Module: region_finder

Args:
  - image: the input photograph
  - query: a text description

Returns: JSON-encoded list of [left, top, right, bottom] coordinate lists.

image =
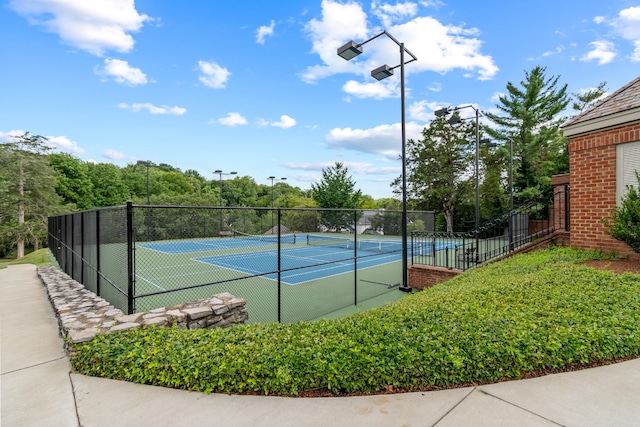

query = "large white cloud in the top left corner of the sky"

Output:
[[9, 0, 151, 56]]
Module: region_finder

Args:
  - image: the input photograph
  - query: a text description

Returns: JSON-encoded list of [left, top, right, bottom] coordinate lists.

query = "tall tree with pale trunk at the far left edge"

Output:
[[0, 132, 62, 258]]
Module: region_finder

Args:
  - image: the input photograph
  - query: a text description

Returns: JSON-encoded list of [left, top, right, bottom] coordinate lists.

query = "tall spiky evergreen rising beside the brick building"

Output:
[[485, 66, 569, 198]]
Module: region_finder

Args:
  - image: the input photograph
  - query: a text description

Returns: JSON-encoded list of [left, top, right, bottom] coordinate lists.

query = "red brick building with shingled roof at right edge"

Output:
[[563, 77, 640, 257]]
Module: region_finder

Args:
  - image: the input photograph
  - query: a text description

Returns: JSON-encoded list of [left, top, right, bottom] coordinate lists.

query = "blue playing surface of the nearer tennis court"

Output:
[[195, 243, 456, 285]]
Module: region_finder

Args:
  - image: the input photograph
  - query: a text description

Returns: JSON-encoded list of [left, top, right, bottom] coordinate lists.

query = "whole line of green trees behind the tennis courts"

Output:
[[0, 66, 606, 257]]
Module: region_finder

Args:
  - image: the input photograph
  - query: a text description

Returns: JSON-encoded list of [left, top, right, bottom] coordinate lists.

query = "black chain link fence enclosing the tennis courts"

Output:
[[49, 203, 435, 323]]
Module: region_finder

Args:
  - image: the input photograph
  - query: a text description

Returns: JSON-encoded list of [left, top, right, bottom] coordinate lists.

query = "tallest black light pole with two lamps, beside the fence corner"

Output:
[[338, 31, 418, 292]]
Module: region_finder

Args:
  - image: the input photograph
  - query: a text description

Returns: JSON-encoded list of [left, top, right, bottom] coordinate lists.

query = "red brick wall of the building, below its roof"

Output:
[[569, 123, 640, 258]]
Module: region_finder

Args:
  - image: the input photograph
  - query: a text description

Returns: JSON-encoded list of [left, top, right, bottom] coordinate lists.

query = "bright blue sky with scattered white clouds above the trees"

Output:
[[0, 0, 640, 198]]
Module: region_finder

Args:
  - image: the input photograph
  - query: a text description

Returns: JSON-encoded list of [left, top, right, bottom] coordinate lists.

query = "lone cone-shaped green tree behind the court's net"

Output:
[[311, 162, 362, 231]]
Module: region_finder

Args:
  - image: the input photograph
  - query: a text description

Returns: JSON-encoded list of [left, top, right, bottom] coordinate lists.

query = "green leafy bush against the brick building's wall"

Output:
[[602, 171, 640, 253]]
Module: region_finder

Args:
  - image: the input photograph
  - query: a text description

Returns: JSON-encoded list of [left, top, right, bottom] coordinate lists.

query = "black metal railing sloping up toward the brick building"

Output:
[[411, 185, 570, 271]]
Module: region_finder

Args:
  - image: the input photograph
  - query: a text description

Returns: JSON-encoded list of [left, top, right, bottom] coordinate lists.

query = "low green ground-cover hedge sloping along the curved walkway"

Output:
[[72, 248, 640, 395]]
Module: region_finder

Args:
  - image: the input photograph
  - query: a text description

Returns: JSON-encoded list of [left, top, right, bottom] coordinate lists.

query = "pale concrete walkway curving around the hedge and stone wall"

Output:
[[0, 265, 640, 427]]
